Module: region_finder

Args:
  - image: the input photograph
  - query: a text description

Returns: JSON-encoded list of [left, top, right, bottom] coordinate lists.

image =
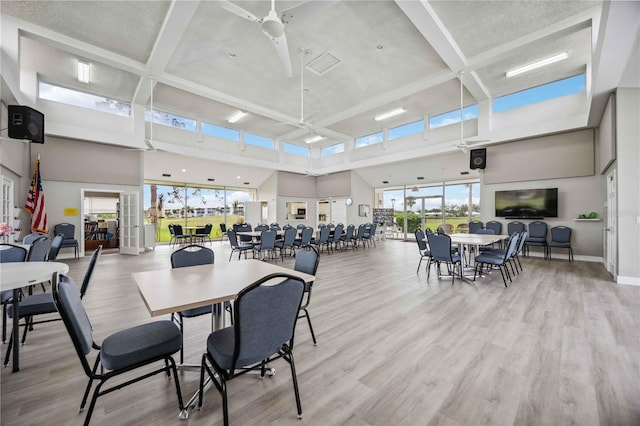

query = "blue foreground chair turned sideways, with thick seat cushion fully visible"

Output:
[[52, 274, 184, 425]]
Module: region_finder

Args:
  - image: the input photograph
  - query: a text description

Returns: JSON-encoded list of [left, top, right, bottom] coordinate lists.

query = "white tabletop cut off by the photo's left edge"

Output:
[[0, 262, 69, 291]]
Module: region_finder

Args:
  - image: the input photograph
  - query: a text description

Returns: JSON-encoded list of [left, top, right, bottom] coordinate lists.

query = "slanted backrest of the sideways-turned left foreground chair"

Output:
[[51, 274, 93, 377]]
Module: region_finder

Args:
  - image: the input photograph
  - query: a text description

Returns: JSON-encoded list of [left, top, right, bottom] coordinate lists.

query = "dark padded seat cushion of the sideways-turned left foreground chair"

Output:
[[100, 321, 182, 370]]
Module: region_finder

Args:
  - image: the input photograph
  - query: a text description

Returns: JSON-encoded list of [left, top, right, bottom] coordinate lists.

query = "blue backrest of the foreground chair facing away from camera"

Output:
[[230, 274, 304, 374]]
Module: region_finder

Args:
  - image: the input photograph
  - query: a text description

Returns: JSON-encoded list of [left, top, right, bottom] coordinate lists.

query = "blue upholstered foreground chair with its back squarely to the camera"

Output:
[[198, 274, 304, 426]]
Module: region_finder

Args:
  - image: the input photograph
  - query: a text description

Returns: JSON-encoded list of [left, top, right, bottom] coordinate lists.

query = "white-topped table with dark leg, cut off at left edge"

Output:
[[0, 262, 69, 372]]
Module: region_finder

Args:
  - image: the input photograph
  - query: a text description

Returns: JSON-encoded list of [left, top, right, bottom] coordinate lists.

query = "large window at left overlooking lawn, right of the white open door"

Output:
[[144, 182, 256, 242]]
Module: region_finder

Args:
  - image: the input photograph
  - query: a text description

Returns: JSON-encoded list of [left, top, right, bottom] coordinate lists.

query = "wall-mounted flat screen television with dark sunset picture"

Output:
[[496, 188, 558, 219]]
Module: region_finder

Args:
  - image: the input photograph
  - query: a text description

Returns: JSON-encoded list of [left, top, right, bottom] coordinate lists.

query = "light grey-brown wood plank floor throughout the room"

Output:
[[0, 240, 640, 425]]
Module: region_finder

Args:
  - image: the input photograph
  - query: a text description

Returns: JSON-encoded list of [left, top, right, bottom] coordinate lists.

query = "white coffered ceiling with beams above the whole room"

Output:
[[1, 0, 637, 188]]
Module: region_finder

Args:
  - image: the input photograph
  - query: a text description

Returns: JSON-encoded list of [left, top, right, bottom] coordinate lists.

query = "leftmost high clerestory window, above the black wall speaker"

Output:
[[38, 82, 131, 117]]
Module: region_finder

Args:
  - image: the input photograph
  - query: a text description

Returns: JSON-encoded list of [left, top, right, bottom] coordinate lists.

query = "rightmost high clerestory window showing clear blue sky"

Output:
[[493, 74, 586, 113]]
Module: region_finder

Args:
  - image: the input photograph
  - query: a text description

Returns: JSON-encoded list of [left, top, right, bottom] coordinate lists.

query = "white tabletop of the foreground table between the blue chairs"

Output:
[[131, 259, 315, 317]]
